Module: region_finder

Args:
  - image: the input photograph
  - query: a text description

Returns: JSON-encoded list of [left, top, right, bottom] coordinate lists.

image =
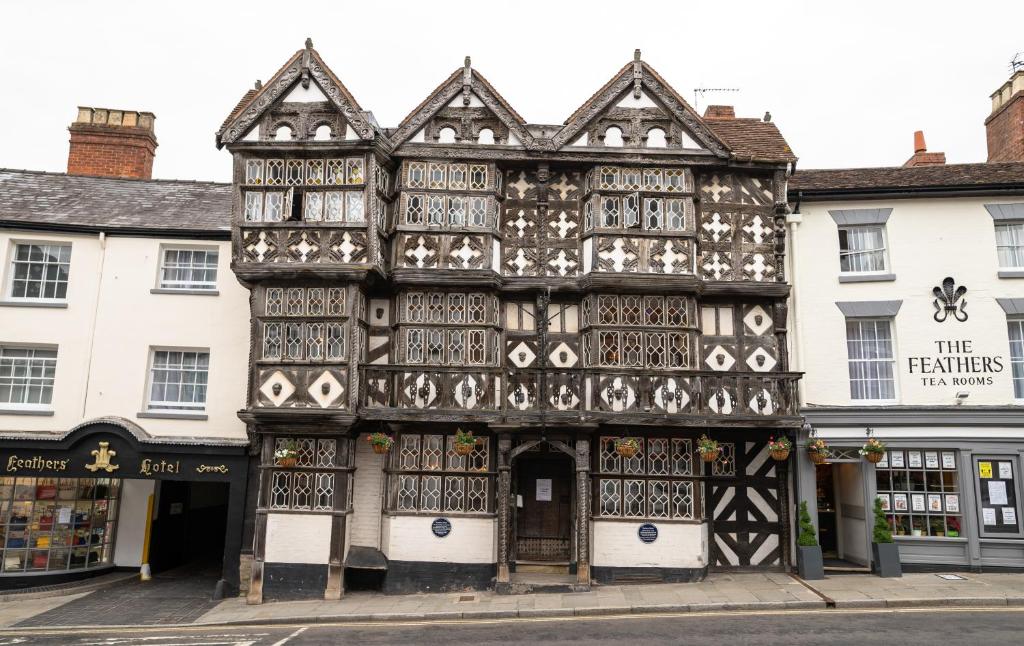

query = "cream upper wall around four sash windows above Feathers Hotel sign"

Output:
[[0, 230, 249, 438]]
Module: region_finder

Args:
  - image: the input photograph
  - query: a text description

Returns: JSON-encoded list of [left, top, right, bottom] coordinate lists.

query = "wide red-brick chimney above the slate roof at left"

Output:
[[68, 106, 157, 179]]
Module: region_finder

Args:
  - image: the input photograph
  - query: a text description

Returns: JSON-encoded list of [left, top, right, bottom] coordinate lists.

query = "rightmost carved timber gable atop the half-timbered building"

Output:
[[552, 50, 729, 157]]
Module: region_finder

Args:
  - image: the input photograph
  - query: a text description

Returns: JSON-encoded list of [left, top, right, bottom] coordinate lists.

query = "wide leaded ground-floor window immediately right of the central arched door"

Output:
[[594, 437, 700, 520]]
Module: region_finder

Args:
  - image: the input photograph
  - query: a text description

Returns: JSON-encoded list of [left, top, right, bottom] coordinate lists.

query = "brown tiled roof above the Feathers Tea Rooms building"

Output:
[[790, 162, 1024, 193]]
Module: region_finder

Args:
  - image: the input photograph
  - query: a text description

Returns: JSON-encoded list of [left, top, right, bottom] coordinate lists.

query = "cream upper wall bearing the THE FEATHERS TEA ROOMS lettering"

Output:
[[792, 198, 1024, 405]]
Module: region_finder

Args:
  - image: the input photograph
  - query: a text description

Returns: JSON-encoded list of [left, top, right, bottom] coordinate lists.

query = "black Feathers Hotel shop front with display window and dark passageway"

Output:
[[0, 418, 247, 595]]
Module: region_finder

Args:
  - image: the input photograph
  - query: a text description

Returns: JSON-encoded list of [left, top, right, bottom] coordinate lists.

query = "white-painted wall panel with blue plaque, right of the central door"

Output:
[[590, 520, 708, 567]]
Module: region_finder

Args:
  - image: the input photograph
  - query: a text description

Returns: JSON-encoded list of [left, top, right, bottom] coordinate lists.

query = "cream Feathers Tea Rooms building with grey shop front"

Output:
[[788, 160, 1024, 569]]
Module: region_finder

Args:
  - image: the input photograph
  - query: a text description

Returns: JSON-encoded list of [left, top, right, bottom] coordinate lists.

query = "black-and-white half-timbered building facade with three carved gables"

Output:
[[217, 42, 800, 602]]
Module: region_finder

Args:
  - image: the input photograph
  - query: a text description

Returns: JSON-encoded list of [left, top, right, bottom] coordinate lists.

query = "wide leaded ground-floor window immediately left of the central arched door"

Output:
[[388, 433, 494, 514]]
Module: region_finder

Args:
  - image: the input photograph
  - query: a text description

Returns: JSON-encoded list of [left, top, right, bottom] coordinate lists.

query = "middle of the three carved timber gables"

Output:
[[391, 56, 532, 146]]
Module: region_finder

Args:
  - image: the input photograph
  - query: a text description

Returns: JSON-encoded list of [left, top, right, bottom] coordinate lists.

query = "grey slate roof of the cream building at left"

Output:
[[0, 169, 231, 238]]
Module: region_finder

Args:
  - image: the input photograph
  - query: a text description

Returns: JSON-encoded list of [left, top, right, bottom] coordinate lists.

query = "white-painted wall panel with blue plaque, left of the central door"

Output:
[[382, 514, 498, 563]]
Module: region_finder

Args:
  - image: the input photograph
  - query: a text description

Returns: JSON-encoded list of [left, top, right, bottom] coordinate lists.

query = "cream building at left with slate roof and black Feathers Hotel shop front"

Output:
[[0, 135, 249, 593]]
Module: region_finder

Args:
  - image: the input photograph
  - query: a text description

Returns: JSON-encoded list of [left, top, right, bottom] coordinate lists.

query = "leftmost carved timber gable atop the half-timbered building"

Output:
[[217, 39, 375, 146]]
